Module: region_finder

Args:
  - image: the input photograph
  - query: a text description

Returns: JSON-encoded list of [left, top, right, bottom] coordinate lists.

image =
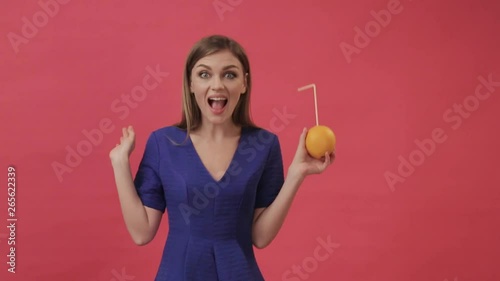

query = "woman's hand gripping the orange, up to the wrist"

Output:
[[288, 128, 335, 178]]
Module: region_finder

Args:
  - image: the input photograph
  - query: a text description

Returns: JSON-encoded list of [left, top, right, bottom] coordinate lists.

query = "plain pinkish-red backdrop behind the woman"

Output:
[[0, 0, 500, 281]]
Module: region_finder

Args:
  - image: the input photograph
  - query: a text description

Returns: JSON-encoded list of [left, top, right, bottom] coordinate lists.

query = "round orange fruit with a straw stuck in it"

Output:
[[306, 125, 336, 159]]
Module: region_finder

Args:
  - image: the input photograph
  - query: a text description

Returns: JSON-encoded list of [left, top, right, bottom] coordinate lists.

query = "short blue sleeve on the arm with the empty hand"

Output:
[[134, 133, 166, 212]]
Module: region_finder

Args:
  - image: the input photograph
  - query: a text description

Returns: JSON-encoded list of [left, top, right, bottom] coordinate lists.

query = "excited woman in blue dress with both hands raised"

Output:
[[110, 35, 334, 281]]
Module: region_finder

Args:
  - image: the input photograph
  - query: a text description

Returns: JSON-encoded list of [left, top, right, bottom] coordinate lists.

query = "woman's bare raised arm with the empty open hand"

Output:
[[110, 127, 163, 245]]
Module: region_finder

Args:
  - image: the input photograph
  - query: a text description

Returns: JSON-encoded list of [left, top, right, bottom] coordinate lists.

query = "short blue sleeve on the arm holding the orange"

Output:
[[255, 135, 284, 208]]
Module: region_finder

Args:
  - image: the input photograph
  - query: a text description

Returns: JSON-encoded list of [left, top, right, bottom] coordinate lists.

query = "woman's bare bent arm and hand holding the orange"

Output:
[[252, 129, 335, 249]]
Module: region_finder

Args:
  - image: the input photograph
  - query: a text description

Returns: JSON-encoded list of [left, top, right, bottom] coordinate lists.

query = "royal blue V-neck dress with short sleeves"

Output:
[[134, 126, 284, 281]]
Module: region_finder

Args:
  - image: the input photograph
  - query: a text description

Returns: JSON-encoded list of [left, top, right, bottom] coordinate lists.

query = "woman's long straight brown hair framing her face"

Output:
[[175, 34, 257, 139]]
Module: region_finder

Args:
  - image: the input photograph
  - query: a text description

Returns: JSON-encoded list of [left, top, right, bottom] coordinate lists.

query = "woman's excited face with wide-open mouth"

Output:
[[190, 50, 246, 124]]
